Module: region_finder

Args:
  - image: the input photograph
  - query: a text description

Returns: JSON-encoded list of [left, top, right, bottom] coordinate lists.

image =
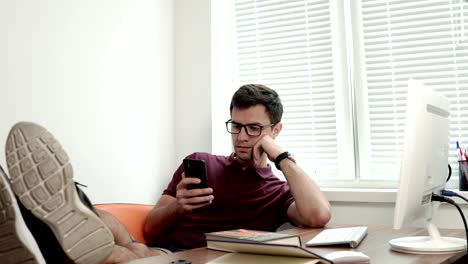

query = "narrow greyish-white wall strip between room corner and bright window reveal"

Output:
[[174, 0, 212, 163]]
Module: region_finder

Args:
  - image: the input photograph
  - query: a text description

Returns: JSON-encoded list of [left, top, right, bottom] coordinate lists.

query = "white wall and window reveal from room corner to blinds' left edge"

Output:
[[174, 0, 238, 160]]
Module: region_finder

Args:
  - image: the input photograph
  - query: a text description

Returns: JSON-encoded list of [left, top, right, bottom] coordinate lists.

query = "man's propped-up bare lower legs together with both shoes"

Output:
[[0, 122, 163, 264]]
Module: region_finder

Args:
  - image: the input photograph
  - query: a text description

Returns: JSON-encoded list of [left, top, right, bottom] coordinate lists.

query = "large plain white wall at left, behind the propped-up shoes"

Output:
[[0, 0, 175, 203]]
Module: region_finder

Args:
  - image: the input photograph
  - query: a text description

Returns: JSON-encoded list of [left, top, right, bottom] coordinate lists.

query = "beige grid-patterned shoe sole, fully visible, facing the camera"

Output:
[[5, 122, 114, 264]]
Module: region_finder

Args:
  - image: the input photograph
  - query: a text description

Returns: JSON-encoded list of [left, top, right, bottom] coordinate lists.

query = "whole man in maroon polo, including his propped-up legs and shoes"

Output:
[[0, 85, 330, 264]]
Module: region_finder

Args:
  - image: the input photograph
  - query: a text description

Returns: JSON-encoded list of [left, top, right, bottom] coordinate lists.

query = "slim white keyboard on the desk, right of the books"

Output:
[[306, 226, 367, 248]]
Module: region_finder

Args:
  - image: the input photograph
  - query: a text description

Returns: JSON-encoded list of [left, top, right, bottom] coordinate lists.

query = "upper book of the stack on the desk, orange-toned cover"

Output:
[[205, 229, 301, 248]]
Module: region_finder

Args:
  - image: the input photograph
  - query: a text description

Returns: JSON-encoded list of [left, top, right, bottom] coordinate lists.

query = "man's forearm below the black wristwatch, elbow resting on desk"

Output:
[[280, 159, 331, 227]]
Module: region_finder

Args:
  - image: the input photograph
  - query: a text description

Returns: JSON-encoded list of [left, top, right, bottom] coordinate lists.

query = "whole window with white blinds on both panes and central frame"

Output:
[[234, 0, 468, 187]]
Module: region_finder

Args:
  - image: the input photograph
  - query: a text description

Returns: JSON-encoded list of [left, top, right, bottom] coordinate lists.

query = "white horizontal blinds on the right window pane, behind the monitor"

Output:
[[358, 0, 468, 180]]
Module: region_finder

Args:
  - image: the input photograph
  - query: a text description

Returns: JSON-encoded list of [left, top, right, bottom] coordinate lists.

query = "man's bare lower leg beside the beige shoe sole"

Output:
[[97, 209, 164, 263]]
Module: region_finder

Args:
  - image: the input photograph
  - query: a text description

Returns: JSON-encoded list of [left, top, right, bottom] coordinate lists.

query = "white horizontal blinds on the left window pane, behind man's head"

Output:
[[235, 0, 337, 178]]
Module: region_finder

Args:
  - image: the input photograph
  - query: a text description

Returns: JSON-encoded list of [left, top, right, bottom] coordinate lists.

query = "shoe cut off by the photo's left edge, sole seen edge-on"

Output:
[[0, 167, 46, 264]]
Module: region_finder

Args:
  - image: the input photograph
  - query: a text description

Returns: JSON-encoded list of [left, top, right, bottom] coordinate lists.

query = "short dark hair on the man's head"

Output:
[[229, 84, 283, 124]]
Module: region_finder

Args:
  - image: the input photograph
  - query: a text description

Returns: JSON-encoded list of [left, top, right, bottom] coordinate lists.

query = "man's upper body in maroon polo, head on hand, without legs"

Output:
[[145, 84, 331, 251]]
